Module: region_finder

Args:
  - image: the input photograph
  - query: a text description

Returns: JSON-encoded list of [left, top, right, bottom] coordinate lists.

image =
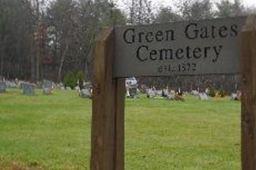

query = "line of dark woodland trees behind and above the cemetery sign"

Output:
[[0, 0, 255, 82]]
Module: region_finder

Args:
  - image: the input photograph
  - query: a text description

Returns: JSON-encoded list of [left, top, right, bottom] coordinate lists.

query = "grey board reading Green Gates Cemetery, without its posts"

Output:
[[113, 17, 246, 77]]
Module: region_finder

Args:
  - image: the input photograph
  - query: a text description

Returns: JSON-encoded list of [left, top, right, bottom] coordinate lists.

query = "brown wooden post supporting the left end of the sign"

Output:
[[91, 28, 125, 170]]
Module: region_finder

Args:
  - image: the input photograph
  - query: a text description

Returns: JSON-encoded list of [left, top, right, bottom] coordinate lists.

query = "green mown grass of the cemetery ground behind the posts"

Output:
[[0, 89, 241, 170]]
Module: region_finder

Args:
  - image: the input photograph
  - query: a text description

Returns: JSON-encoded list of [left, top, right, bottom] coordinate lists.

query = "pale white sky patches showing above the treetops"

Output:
[[114, 0, 256, 10]]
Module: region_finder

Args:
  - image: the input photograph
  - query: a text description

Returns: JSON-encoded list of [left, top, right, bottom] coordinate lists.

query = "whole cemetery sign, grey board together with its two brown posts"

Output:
[[91, 16, 256, 170]]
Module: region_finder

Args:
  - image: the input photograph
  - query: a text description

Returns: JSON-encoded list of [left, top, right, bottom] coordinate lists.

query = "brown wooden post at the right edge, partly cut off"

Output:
[[241, 17, 256, 170]]
